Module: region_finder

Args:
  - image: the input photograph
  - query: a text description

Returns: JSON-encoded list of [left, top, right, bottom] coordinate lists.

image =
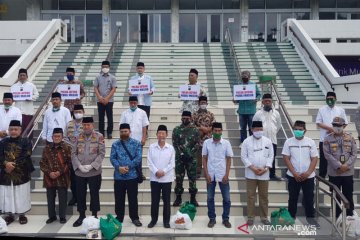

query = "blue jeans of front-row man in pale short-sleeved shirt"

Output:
[[207, 181, 231, 221]]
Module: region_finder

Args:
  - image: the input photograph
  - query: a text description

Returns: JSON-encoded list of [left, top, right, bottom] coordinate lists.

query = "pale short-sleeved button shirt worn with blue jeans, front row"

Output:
[[202, 138, 234, 182]]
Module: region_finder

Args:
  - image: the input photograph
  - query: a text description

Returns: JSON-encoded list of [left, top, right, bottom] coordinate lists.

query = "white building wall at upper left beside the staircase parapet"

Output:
[[0, 21, 50, 56]]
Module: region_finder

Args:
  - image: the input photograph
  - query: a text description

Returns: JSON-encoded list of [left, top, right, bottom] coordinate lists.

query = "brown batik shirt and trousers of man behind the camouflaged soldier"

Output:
[[193, 109, 215, 176]]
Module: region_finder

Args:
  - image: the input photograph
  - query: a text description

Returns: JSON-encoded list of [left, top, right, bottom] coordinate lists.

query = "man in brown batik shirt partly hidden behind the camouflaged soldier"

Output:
[[193, 96, 215, 178]]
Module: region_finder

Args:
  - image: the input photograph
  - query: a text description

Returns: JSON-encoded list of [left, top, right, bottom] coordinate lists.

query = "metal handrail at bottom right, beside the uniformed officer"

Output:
[[315, 175, 350, 240]]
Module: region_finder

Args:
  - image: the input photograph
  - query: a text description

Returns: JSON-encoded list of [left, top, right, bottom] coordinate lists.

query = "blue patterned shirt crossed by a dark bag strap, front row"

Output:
[[110, 138, 142, 180]]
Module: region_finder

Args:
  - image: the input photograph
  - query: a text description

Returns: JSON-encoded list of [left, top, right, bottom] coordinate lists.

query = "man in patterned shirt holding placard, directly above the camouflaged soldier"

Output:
[[179, 68, 206, 113]]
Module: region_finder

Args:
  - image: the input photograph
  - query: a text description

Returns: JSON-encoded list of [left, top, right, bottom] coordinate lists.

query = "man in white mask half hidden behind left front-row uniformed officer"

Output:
[[64, 104, 85, 206]]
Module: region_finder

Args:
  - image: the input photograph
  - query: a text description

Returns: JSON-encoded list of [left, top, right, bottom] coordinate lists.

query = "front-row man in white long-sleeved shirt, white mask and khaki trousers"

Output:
[[241, 121, 274, 226]]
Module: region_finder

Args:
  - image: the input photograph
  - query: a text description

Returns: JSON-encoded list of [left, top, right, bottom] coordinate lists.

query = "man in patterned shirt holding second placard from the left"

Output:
[[60, 67, 85, 114]]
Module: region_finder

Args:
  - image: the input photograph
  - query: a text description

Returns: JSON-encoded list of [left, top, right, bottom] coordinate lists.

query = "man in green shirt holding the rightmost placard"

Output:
[[234, 70, 261, 147]]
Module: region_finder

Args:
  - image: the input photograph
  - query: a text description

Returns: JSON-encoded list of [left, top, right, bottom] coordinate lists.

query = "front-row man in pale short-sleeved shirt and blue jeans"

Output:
[[202, 122, 234, 228]]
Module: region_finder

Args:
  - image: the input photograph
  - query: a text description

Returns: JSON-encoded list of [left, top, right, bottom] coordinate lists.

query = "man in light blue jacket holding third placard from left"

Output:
[[129, 62, 155, 119]]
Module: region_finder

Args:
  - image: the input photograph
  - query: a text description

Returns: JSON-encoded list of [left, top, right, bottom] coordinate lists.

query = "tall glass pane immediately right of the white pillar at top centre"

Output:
[[179, 14, 195, 42]]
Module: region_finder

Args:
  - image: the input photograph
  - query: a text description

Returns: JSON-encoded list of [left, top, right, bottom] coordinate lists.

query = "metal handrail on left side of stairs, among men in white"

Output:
[[22, 80, 60, 150]]
